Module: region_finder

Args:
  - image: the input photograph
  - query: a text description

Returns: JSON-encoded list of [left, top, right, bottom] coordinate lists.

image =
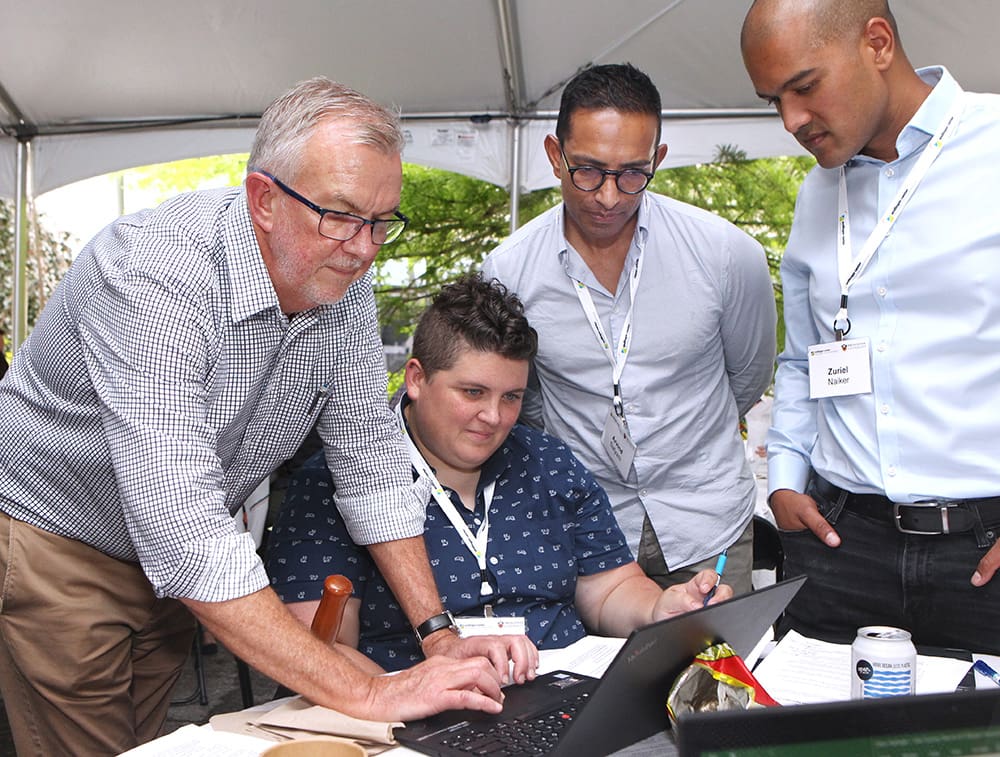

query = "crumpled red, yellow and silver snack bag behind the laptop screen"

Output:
[[667, 642, 778, 725]]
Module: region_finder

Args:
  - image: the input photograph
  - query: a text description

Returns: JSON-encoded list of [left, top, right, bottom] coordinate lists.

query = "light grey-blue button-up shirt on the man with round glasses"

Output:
[[483, 192, 775, 569]]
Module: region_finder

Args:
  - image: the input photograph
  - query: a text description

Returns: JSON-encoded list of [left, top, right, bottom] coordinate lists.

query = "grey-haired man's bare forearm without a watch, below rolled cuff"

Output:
[[181, 588, 372, 718]]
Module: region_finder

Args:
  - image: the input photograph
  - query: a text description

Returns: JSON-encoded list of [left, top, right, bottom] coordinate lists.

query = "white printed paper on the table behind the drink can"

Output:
[[753, 631, 972, 704]]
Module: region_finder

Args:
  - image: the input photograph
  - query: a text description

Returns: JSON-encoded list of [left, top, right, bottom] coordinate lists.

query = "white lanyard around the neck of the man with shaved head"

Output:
[[833, 96, 964, 341]]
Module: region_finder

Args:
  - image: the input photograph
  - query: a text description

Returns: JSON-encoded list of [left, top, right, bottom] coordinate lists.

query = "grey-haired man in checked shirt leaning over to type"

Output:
[[0, 79, 534, 755]]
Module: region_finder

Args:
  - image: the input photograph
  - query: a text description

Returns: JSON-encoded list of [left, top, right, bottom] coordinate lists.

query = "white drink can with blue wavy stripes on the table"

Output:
[[851, 626, 917, 699]]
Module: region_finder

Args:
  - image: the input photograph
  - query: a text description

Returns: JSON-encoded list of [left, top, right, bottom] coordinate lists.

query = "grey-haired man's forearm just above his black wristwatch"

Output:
[[368, 536, 444, 627]]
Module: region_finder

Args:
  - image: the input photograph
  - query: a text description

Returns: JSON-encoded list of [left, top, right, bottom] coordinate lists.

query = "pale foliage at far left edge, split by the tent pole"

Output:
[[0, 200, 73, 346]]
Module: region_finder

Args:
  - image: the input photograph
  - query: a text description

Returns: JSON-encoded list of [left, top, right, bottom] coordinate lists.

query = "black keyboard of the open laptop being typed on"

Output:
[[442, 693, 590, 757]]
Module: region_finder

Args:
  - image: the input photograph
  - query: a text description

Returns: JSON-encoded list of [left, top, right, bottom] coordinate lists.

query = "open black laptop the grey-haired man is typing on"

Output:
[[394, 576, 806, 757]]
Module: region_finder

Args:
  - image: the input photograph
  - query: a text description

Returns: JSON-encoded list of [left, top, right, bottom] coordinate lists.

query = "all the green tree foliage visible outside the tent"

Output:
[[0, 146, 814, 366]]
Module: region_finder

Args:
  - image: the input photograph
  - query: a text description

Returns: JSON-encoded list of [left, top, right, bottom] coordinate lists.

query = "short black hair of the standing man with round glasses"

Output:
[[556, 63, 662, 144]]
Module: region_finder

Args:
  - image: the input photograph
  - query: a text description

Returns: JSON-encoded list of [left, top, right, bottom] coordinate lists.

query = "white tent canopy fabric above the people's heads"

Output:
[[0, 0, 1000, 196]]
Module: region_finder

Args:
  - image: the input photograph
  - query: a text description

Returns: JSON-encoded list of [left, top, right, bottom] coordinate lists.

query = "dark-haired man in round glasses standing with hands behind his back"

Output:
[[483, 65, 775, 592]]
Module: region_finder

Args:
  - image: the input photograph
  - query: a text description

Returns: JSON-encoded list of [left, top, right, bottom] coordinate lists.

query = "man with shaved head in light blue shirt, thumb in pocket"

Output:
[[742, 0, 1000, 653]]
